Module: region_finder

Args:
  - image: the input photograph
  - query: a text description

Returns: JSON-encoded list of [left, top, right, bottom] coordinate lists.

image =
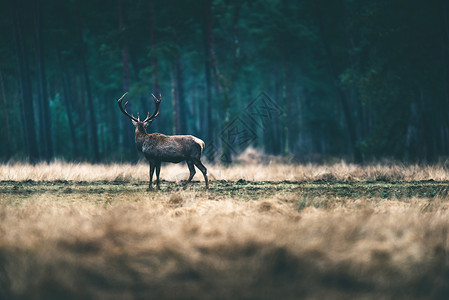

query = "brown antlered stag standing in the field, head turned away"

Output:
[[117, 92, 209, 190]]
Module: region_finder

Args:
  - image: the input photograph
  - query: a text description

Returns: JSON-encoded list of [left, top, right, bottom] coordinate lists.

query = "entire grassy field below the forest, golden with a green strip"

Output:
[[0, 162, 449, 299]]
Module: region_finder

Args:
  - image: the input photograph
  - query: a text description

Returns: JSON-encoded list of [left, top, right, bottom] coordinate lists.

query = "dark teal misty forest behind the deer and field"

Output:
[[0, 0, 449, 163]]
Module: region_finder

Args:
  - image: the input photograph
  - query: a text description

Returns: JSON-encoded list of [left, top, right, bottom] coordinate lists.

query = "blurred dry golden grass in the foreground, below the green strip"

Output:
[[0, 191, 449, 299]]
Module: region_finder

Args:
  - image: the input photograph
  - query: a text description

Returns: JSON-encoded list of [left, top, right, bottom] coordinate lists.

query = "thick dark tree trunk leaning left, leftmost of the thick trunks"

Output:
[[10, 0, 39, 163]]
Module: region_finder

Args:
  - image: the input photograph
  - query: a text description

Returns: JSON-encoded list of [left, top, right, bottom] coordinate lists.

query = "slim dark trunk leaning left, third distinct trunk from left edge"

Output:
[[76, 0, 100, 162]]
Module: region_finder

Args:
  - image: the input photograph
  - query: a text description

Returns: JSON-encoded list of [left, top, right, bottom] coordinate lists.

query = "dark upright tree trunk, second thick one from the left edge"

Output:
[[34, 0, 54, 162]]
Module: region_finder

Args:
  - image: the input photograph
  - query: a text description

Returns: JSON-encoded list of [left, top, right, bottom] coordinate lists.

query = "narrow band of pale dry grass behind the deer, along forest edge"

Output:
[[0, 161, 449, 181]]
